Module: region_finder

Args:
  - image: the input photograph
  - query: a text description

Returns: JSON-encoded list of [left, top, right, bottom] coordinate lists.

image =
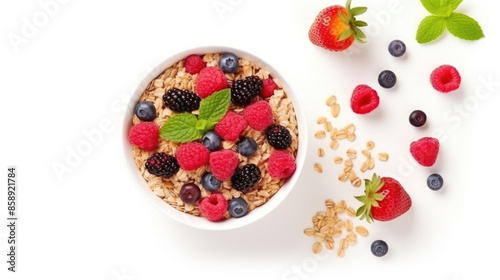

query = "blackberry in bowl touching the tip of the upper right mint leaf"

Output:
[[231, 76, 263, 106]]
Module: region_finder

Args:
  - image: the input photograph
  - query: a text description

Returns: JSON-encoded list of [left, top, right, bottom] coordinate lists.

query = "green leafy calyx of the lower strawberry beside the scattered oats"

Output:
[[355, 174, 385, 223]]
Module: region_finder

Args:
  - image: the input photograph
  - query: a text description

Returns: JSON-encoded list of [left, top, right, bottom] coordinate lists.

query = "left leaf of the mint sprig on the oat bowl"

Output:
[[160, 113, 204, 143]]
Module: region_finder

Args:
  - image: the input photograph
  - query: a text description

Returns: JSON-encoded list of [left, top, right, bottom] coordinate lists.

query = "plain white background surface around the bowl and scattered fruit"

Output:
[[0, 0, 500, 280]]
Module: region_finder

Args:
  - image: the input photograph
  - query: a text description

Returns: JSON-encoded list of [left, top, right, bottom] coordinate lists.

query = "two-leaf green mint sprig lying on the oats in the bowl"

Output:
[[160, 89, 231, 143]]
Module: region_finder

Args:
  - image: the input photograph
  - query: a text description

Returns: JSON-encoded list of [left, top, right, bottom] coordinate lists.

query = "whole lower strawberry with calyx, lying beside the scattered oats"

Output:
[[356, 174, 411, 222]]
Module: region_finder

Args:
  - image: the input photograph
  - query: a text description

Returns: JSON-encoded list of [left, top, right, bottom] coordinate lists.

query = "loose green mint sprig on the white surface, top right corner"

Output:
[[417, 0, 484, 44]]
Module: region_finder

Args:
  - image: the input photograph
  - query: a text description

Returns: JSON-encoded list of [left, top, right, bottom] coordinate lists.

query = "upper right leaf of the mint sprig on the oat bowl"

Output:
[[198, 89, 231, 130]]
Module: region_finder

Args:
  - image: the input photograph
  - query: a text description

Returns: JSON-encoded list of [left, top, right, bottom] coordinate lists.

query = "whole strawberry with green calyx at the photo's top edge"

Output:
[[309, 0, 368, 52]]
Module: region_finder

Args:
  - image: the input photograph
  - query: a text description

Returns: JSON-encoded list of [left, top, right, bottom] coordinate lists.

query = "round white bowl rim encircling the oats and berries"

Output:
[[122, 46, 307, 230]]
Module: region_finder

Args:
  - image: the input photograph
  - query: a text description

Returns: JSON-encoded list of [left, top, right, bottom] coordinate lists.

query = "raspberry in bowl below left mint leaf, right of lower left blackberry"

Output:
[[177, 142, 210, 171]]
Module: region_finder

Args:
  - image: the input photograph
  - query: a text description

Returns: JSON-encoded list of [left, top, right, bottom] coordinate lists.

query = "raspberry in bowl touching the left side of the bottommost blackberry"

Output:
[[210, 150, 240, 181]]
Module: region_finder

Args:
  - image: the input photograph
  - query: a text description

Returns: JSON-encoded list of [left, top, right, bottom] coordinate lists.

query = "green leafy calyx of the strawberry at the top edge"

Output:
[[338, 0, 368, 43]]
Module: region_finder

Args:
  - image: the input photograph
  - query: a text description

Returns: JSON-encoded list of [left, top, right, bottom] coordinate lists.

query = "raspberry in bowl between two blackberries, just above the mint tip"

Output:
[[195, 67, 227, 98]]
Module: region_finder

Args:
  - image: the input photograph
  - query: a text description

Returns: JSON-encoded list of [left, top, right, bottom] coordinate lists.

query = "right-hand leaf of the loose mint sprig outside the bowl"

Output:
[[446, 13, 484, 40]]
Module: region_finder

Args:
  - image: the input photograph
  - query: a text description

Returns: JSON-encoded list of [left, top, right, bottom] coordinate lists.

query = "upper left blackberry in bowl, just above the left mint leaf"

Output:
[[163, 88, 201, 112]]
